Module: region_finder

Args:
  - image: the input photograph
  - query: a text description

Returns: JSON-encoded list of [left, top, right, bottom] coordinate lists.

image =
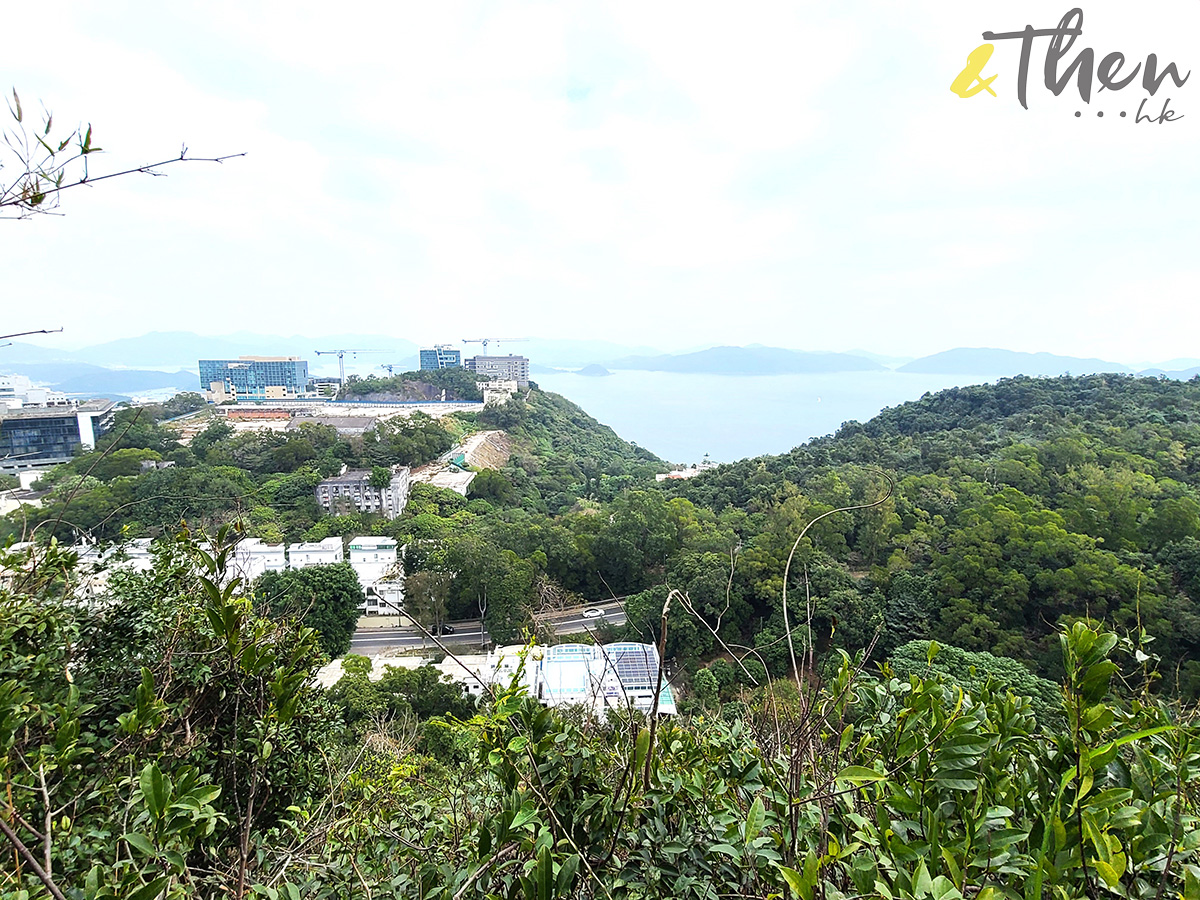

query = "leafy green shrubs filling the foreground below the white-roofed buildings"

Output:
[[0, 532, 1200, 900]]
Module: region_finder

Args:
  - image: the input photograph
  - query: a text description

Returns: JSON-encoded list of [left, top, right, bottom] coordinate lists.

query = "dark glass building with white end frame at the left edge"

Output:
[[0, 400, 115, 473]]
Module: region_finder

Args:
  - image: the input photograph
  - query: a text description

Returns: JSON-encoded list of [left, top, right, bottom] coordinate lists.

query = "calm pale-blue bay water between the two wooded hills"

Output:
[[534, 370, 1001, 463]]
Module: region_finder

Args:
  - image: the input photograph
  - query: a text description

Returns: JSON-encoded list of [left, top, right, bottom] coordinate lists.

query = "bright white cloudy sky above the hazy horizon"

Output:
[[0, 0, 1200, 362]]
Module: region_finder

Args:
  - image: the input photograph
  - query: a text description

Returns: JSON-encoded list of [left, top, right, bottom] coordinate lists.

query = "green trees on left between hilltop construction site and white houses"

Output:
[[11, 407, 454, 542]]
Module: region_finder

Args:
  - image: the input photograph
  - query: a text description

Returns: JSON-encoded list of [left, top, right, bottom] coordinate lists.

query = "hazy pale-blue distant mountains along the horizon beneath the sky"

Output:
[[0, 331, 1200, 396]]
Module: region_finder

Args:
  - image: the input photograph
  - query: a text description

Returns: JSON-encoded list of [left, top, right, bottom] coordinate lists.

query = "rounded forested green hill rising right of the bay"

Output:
[[668, 374, 1200, 695]]
